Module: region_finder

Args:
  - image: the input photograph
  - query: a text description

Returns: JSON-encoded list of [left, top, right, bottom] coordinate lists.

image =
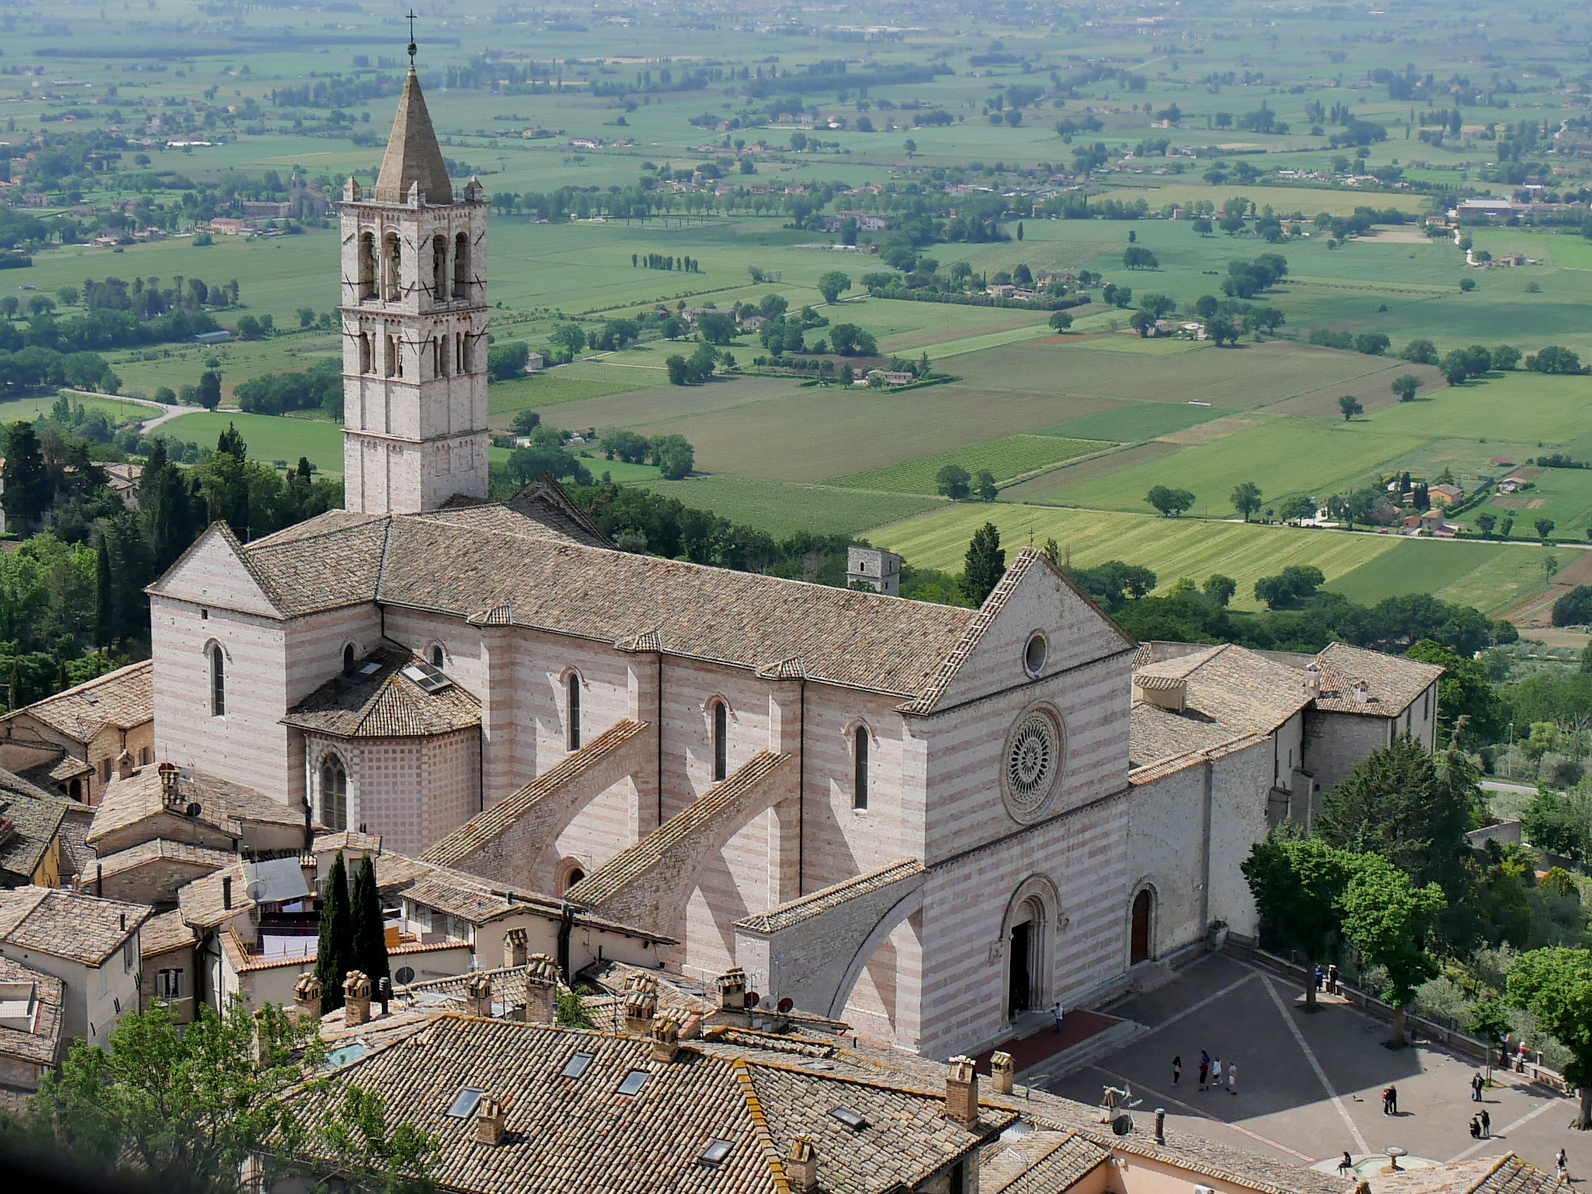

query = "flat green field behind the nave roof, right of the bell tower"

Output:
[[633, 474, 944, 538]]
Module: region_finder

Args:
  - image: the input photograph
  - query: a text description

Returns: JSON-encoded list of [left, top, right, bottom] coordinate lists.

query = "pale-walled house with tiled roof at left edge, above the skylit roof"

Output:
[[0, 887, 150, 1046]]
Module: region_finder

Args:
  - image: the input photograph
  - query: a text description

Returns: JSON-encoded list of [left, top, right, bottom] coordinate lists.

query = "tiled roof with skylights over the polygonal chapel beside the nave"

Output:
[[282, 645, 481, 739]]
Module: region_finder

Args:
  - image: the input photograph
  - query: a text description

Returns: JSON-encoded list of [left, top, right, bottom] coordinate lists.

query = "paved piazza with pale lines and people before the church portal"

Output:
[[1019, 954, 1592, 1189]]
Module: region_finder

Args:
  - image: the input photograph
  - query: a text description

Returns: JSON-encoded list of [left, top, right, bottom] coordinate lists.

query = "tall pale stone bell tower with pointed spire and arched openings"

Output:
[[339, 41, 487, 514]]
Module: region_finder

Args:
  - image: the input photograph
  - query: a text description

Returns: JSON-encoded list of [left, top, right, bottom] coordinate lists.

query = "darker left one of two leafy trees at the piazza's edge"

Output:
[[1239, 837, 1355, 1011]]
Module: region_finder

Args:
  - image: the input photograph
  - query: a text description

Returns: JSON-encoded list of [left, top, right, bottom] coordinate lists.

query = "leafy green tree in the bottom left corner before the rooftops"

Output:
[[0, 997, 438, 1194]]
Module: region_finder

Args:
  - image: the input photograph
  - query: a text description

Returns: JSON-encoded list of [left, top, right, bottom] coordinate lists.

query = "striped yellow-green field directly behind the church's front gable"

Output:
[[869, 501, 1399, 608]]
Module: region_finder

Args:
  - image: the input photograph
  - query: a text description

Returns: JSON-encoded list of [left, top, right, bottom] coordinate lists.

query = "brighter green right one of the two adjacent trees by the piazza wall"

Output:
[[1340, 856, 1449, 1048]]
